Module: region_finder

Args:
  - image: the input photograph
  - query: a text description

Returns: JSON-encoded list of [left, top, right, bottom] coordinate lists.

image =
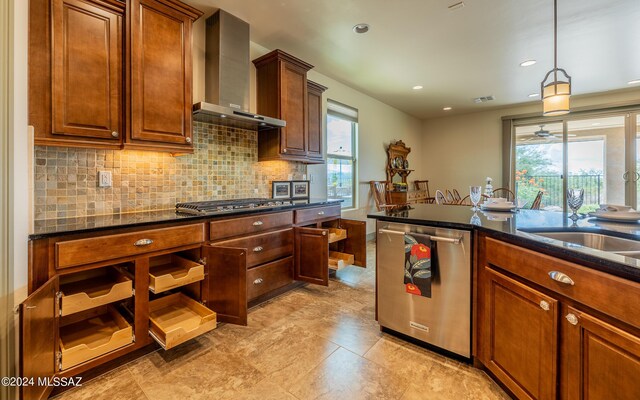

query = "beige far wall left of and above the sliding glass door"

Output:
[[420, 90, 640, 195]]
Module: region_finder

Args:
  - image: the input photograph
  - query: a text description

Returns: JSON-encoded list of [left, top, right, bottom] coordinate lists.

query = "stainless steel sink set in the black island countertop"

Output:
[[529, 232, 640, 253]]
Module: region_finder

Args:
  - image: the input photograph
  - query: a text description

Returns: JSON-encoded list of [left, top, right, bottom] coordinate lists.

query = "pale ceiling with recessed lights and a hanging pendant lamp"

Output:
[[185, 0, 640, 118]]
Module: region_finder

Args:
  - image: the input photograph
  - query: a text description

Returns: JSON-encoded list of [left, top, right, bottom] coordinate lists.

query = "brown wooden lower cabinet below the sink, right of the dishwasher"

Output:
[[476, 235, 640, 400]]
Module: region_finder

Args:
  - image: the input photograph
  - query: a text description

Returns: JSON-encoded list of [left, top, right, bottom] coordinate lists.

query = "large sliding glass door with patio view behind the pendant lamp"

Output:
[[511, 109, 640, 213]]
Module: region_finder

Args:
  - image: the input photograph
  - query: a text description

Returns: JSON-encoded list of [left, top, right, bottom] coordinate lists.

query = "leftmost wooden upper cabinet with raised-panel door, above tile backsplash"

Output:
[[29, 0, 125, 148]]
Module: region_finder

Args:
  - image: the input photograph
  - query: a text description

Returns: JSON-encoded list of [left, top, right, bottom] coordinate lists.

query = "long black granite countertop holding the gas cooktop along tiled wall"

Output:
[[29, 198, 342, 240]]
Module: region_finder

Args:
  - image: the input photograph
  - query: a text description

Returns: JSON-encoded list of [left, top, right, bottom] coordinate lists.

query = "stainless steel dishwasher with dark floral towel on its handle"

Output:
[[376, 221, 471, 358]]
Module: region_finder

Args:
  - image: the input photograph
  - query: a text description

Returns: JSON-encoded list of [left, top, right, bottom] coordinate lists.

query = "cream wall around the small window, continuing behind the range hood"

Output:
[[193, 18, 426, 233]]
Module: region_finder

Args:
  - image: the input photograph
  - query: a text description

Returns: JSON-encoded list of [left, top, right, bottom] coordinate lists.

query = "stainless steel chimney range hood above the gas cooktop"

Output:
[[193, 10, 286, 130]]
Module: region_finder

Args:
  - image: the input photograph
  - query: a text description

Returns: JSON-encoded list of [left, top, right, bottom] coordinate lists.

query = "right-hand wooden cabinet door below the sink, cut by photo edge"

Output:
[[561, 307, 640, 400]]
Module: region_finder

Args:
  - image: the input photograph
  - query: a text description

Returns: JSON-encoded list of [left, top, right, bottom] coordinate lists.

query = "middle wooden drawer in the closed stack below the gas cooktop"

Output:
[[216, 228, 293, 268]]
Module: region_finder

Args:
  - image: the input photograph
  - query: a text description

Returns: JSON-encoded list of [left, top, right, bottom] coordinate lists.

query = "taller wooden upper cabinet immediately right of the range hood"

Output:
[[253, 50, 313, 162]]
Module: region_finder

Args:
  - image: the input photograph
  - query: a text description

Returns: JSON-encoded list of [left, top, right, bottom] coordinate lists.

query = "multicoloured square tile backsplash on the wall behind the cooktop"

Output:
[[34, 122, 307, 220]]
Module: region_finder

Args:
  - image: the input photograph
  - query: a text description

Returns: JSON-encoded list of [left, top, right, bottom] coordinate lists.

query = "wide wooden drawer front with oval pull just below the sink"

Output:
[[486, 238, 640, 326]]
